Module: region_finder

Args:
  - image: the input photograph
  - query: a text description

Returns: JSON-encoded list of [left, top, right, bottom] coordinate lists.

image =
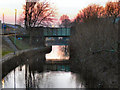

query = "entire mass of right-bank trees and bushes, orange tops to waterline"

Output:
[[70, 2, 120, 88]]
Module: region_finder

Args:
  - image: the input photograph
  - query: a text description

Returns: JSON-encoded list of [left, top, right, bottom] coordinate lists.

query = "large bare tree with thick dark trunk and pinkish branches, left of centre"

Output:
[[20, 1, 56, 28]]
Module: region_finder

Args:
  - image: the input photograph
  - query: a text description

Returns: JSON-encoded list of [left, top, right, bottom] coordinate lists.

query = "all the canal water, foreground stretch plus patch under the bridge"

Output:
[[2, 46, 85, 88]]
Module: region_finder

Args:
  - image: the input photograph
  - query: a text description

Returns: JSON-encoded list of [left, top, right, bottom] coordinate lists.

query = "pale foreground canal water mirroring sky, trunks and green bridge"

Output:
[[3, 65, 84, 88]]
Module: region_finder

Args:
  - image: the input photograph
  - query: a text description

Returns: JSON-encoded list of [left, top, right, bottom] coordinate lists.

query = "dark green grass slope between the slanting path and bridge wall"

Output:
[[10, 36, 31, 50]]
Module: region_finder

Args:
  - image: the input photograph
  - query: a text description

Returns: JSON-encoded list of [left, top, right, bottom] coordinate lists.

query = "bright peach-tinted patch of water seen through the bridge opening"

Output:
[[46, 45, 69, 61]]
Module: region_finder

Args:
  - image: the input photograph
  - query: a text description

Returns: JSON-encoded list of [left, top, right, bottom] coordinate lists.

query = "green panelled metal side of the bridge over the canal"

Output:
[[44, 27, 70, 37]]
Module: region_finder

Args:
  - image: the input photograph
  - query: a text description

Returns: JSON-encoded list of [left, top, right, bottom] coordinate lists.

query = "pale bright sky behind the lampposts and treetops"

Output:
[[0, 0, 114, 24]]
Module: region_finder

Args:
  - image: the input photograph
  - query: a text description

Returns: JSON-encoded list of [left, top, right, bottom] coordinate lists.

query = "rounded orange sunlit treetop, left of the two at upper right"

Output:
[[76, 4, 104, 22]]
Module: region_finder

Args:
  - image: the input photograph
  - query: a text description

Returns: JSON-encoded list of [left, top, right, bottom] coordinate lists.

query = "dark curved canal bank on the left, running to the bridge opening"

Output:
[[2, 46, 52, 78]]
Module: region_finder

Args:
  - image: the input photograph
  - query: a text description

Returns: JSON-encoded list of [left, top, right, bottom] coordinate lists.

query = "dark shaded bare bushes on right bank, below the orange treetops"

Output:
[[70, 19, 119, 88]]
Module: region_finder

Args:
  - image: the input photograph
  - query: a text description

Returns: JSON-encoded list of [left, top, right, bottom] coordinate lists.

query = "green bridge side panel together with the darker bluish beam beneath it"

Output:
[[44, 27, 70, 45]]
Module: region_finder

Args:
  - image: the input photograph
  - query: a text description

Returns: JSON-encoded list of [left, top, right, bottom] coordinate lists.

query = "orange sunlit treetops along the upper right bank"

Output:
[[75, 2, 120, 22]]
